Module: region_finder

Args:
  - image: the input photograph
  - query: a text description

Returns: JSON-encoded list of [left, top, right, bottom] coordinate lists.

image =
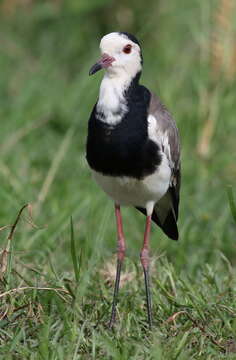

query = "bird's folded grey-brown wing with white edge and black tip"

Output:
[[148, 94, 181, 239]]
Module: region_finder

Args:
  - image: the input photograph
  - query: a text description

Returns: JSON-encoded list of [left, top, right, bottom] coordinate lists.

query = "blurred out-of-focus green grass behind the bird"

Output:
[[0, 0, 236, 358]]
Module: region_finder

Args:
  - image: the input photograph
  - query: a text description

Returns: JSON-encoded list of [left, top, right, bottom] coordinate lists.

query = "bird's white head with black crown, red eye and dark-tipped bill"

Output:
[[89, 32, 142, 78]]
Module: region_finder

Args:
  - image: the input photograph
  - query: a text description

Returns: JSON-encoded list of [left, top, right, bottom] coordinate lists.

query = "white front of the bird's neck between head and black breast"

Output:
[[96, 72, 141, 126]]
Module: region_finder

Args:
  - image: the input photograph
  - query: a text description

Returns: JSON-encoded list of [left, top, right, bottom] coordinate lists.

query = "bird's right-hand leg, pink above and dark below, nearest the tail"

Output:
[[140, 216, 152, 329]]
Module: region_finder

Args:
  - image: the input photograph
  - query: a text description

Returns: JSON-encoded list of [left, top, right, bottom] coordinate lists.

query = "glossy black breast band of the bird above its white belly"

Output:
[[86, 85, 161, 179]]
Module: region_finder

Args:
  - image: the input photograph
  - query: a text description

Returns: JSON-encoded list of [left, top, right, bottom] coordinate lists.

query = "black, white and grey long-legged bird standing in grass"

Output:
[[86, 32, 181, 329]]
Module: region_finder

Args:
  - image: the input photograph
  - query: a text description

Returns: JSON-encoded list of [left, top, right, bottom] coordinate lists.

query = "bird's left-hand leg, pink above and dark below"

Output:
[[109, 204, 125, 328]]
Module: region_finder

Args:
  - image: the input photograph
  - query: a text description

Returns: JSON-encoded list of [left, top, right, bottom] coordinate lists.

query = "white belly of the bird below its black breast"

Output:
[[93, 154, 171, 208]]
